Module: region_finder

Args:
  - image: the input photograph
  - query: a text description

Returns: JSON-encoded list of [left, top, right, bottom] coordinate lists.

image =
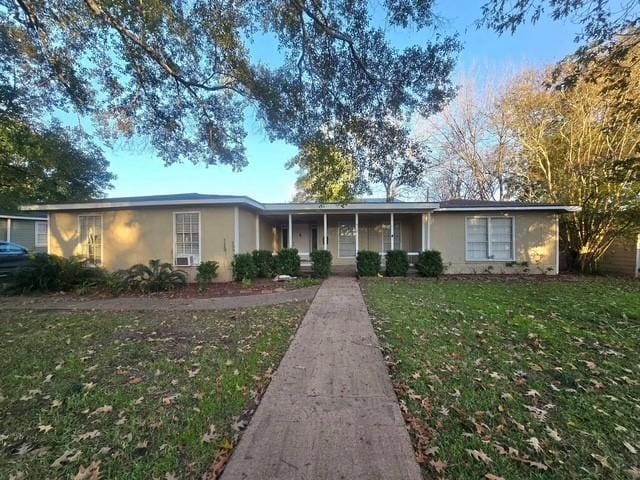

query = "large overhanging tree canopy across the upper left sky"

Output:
[[0, 0, 459, 169]]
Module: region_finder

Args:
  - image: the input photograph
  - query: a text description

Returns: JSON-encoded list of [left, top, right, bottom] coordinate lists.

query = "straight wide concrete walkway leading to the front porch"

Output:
[[222, 277, 421, 480]]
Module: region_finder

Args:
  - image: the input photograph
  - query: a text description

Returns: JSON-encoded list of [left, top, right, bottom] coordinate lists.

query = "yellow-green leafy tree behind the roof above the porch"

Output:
[[287, 134, 367, 203]]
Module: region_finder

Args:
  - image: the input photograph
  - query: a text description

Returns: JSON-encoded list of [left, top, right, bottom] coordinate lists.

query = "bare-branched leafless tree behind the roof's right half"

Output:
[[418, 74, 514, 200]]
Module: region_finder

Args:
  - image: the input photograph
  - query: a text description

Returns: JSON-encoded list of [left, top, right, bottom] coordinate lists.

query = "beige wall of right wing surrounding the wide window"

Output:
[[431, 212, 557, 274]]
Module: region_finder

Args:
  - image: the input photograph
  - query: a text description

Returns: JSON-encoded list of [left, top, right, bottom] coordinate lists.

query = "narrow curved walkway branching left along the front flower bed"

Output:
[[0, 287, 318, 311]]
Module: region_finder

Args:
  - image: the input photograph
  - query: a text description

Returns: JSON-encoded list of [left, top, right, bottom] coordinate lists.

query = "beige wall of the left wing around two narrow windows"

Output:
[[50, 206, 238, 281]]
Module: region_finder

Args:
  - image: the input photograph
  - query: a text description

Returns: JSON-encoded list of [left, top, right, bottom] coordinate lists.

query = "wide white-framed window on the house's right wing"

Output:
[[465, 217, 514, 261]]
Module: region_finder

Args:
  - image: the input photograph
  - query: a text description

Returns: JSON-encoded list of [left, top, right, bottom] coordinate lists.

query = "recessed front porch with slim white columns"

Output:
[[256, 212, 430, 271]]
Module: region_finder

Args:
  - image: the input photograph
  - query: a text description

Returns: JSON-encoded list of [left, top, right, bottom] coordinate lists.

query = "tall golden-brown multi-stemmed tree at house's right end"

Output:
[[503, 57, 640, 271]]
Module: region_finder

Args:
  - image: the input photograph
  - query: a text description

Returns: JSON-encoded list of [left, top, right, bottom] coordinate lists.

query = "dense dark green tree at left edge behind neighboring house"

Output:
[[0, 118, 115, 209]]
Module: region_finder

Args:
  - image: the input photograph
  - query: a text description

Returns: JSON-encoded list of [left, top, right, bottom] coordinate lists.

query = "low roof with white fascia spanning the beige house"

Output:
[[21, 193, 579, 213]]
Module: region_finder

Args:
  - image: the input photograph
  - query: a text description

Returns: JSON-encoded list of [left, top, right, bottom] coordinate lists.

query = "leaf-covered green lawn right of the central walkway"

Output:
[[363, 279, 640, 479]]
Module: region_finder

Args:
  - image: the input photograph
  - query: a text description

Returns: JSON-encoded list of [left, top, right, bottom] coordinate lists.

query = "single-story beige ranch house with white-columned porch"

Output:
[[23, 193, 577, 281]]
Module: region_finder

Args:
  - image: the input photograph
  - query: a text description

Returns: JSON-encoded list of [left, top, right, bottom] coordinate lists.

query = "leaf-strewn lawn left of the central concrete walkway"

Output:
[[0, 303, 306, 479]]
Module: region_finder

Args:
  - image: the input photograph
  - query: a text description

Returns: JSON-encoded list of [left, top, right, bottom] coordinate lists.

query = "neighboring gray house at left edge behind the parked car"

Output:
[[0, 211, 49, 252]]
